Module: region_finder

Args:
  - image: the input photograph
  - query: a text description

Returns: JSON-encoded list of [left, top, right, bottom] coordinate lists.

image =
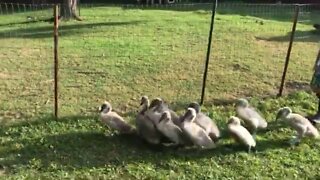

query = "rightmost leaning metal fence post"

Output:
[[278, 4, 300, 97]]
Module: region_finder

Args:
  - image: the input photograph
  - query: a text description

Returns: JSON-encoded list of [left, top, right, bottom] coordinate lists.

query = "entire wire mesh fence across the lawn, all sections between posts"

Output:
[[0, 3, 320, 119]]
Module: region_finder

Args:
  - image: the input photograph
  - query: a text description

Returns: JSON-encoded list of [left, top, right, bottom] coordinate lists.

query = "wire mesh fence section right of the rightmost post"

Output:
[[288, 5, 320, 90]]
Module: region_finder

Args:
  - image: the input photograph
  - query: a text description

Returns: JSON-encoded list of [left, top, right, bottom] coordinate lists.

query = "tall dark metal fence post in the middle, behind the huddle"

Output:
[[200, 0, 218, 105]]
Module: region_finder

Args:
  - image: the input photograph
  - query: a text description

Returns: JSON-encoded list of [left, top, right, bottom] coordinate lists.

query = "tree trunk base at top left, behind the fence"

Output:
[[59, 0, 82, 21]]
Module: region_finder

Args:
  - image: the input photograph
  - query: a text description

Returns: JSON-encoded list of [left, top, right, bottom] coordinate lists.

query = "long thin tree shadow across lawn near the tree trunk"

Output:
[[0, 21, 142, 39]]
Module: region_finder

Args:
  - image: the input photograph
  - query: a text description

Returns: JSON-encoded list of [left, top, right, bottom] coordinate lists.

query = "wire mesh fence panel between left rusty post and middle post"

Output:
[[59, 5, 210, 116]]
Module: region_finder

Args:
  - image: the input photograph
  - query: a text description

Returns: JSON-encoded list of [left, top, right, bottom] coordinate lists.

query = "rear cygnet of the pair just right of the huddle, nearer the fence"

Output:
[[236, 98, 268, 138]]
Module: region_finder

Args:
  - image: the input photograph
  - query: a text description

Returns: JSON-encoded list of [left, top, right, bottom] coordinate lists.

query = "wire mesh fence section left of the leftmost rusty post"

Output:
[[0, 4, 53, 121]]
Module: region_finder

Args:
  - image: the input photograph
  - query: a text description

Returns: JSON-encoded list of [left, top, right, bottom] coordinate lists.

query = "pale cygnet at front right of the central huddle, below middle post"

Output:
[[181, 108, 216, 149]]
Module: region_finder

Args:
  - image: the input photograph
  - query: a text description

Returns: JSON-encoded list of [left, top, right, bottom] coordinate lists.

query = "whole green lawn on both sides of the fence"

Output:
[[0, 2, 320, 179]]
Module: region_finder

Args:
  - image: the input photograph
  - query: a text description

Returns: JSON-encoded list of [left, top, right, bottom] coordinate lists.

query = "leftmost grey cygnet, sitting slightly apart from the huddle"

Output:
[[99, 101, 135, 134]]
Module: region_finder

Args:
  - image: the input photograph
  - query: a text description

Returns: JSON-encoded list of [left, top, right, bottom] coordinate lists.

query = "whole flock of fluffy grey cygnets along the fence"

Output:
[[99, 96, 319, 153]]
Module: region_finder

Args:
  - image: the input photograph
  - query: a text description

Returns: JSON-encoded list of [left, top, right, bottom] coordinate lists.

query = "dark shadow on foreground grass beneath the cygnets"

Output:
[[0, 113, 286, 171]]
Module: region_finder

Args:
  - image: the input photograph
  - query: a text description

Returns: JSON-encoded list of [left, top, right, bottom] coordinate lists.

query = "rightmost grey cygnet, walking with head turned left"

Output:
[[276, 107, 319, 145]]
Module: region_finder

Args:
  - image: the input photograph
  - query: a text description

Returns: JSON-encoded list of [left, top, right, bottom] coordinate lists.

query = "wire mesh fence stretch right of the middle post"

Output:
[[207, 4, 320, 100]]
